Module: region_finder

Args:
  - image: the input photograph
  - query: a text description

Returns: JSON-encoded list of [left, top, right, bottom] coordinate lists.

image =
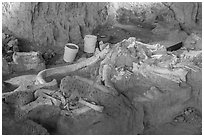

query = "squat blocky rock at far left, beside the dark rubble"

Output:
[[13, 52, 45, 72]]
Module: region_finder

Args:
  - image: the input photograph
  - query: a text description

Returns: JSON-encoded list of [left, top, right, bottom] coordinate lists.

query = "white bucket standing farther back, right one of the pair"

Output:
[[84, 35, 97, 53]]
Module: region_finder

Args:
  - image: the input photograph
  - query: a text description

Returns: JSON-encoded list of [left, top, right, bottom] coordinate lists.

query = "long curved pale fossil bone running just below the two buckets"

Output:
[[36, 46, 110, 84]]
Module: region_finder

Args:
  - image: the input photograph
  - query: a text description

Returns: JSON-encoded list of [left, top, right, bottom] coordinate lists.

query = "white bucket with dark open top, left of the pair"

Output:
[[63, 43, 79, 63]]
